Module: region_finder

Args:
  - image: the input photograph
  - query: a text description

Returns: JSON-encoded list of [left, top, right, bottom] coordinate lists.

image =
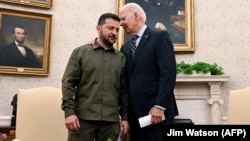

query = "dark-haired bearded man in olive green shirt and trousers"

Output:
[[62, 13, 129, 141]]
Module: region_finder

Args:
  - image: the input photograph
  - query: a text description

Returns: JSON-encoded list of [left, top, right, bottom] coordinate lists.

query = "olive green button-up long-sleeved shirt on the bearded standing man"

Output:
[[62, 43, 128, 122]]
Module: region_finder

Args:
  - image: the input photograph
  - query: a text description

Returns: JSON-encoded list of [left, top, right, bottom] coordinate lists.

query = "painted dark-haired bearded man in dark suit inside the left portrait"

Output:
[[0, 26, 41, 68]]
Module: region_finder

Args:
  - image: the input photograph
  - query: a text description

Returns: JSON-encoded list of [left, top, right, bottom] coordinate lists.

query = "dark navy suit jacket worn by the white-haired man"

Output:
[[121, 27, 178, 121]]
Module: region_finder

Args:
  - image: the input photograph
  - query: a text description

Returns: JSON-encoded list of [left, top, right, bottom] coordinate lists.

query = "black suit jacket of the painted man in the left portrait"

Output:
[[0, 42, 41, 68]]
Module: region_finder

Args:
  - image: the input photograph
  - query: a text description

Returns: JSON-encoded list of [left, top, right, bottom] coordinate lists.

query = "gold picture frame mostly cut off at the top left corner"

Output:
[[0, 0, 52, 8]]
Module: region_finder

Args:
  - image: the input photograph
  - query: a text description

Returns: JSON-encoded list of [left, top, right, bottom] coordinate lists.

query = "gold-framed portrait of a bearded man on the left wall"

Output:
[[0, 8, 52, 75]]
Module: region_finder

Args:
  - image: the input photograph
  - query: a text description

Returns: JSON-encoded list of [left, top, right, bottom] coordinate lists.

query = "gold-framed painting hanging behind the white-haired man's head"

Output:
[[117, 0, 195, 53]]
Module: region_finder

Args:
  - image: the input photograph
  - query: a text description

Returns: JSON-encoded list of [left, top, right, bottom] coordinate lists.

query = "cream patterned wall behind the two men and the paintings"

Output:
[[0, 0, 250, 123]]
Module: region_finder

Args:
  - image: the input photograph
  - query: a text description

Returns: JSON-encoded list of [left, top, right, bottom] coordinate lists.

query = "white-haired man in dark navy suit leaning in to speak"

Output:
[[119, 3, 178, 141]]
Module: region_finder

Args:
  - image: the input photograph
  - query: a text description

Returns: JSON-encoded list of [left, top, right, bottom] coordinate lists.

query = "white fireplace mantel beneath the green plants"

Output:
[[175, 75, 230, 124]]
